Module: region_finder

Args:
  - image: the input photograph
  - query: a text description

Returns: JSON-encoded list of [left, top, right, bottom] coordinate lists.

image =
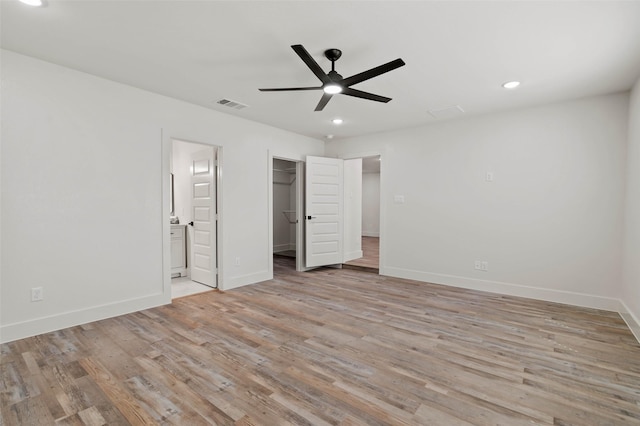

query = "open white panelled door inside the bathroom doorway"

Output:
[[190, 147, 217, 287]]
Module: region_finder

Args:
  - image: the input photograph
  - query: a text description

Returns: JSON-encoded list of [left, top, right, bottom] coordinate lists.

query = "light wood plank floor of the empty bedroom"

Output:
[[0, 257, 640, 426]]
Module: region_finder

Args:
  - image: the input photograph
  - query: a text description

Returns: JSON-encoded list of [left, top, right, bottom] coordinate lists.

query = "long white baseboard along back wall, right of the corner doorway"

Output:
[[380, 267, 625, 312]]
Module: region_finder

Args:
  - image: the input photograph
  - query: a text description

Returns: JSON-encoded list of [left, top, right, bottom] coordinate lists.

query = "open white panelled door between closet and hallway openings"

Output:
[[305, 156, 344, 268]]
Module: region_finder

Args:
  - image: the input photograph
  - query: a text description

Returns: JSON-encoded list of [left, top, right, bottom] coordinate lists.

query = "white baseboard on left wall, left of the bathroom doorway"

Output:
[[0, 294, 171, 343]]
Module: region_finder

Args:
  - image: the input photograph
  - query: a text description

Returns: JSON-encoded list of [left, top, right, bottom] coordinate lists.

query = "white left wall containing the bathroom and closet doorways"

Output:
[[0, 50, 324, 341]]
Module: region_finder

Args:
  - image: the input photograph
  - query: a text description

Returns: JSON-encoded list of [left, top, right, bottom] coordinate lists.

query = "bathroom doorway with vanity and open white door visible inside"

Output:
[[170, 139, 220, 298]]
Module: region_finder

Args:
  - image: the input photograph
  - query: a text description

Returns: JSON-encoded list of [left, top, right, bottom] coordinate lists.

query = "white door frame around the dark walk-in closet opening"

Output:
[[267, 150, 311, 279]]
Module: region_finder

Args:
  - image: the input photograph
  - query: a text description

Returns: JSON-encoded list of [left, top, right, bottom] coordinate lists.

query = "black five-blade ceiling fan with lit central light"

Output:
[[258, 44, 404, 111]]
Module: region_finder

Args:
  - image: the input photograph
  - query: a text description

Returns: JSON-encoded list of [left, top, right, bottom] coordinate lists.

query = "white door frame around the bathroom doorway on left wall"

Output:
[[160, 136, 224, 303]]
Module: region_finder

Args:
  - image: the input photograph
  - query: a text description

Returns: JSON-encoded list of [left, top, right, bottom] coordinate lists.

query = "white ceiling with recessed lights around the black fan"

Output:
[[0, 0, 640, 139]]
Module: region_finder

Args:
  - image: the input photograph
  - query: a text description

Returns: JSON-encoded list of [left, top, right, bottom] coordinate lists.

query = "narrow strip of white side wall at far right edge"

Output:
[[622, 79, 640, 340]]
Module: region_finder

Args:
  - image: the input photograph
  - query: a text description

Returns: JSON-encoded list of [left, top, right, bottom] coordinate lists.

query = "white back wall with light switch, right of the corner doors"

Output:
[[327, 94, 628, 310]]
